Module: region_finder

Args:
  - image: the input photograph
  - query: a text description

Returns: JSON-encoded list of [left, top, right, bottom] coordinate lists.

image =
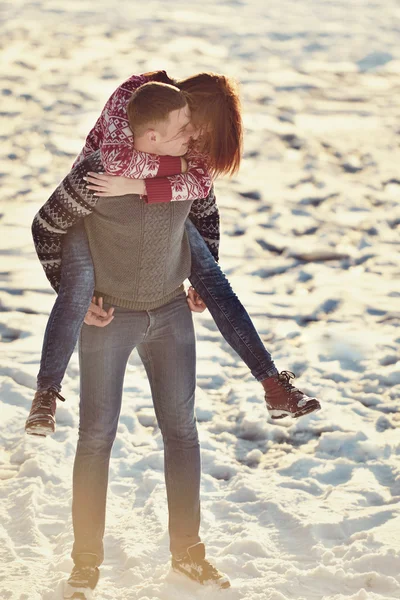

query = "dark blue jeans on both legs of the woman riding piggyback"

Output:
[[38, 219, 277, 392]]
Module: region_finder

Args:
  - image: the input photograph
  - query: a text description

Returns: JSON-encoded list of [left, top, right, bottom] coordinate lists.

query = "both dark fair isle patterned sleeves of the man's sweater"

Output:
[[32, 150, 219, 292]]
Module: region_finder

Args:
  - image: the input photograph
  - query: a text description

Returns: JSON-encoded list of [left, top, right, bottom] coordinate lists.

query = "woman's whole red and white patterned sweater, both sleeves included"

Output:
[[73, 72, 212, 204]]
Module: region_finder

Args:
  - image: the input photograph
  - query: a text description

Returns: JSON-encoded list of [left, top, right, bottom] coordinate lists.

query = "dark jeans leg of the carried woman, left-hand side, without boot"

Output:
[[37, 222, 94, 392]]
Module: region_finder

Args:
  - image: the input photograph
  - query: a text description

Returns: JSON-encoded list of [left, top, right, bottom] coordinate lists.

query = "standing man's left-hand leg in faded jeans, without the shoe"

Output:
[[72, 308, 148, 566]]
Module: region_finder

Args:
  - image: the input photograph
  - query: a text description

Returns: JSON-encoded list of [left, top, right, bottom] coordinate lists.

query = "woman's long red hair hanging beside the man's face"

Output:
[[176, 73, 243, 175]]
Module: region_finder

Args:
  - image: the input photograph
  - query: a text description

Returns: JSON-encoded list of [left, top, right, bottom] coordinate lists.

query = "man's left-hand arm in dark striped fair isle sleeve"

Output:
[[32, 159, 101, 293]]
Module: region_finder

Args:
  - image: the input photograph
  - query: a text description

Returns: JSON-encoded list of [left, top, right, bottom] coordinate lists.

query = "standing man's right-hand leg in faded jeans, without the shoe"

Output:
[[137, 294, 200, 555]]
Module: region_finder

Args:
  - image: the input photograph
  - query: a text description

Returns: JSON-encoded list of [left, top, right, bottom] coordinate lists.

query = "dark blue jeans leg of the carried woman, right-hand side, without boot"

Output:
[[186, 219, 278, 381]]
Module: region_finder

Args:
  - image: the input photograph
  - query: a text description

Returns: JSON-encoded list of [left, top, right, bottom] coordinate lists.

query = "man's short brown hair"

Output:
[[127, 81, 188, 135]]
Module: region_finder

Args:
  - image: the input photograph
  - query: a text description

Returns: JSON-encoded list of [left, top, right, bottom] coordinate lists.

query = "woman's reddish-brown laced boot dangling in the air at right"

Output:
[[263, 371, 321, 419]]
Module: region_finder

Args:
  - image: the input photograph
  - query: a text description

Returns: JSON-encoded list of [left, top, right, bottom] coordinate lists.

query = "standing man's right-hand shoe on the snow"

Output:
[[172, 543, 231, 588]]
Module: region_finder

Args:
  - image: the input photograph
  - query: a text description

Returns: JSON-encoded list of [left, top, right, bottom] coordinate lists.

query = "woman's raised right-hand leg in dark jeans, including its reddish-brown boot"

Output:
[[186, 219, 321, 419]]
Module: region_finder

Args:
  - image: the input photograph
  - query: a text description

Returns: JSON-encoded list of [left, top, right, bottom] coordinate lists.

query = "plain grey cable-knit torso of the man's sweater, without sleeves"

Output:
[[84, 195, 192, 310]]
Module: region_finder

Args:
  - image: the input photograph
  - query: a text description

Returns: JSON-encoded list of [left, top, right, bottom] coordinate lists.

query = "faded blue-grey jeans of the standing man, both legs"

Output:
[[72, 293, 200, 565]]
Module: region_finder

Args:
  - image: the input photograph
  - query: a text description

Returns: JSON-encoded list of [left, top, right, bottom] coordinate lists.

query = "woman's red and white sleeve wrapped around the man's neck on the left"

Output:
[[73, 75, 181, 179]]
